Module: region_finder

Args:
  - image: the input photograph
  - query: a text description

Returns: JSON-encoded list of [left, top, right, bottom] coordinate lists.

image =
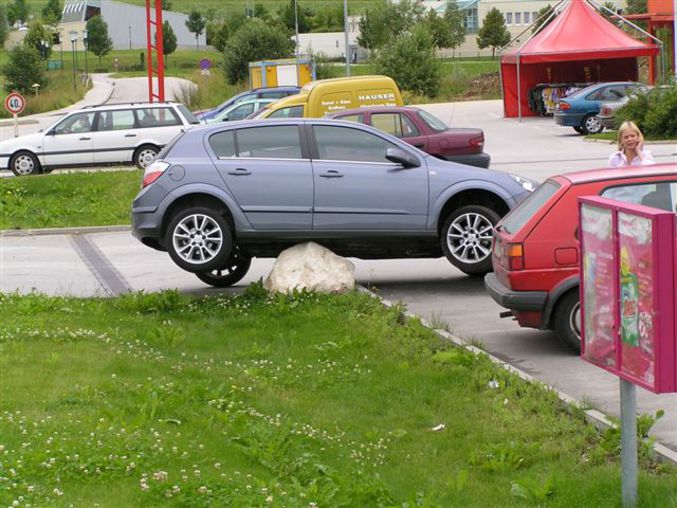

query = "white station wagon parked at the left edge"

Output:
[[0, 102, 200, 176]]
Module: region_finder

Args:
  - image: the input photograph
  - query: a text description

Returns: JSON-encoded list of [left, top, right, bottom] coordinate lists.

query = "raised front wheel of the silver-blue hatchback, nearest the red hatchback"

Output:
[[440, 205, 501, 275]]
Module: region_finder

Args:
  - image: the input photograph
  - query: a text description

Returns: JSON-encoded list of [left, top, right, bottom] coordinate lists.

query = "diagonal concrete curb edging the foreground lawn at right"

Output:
[[359, 286, 677, 465]]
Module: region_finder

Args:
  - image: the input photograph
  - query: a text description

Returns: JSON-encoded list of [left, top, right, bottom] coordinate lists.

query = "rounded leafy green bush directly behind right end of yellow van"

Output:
[[376, 24, 441, 97]]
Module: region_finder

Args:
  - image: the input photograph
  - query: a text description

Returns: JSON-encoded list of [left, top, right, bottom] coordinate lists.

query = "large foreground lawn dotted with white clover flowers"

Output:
[[0, 285, 677, 508]]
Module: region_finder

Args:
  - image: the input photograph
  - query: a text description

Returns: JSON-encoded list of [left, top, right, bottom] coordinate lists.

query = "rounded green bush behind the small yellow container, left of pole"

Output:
[[224, 18, 294, 84]]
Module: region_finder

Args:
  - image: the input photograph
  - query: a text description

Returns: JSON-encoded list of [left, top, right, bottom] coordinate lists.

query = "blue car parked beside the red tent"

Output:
[[555, 81, 646, 134]]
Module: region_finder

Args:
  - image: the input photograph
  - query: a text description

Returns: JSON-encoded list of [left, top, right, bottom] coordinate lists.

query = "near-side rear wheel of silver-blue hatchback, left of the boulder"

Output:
[[165, 207, 233, 273]]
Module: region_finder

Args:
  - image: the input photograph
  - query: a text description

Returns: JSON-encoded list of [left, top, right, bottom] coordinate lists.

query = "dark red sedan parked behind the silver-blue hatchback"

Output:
[[326, 106, 491, 168]]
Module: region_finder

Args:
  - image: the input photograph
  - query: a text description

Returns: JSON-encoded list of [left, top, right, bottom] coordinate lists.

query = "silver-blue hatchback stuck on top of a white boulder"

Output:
[[132, 119, 535, 287]]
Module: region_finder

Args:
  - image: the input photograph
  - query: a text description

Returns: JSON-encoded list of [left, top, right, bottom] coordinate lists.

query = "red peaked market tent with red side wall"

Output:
[[501, 0, 658, 117]]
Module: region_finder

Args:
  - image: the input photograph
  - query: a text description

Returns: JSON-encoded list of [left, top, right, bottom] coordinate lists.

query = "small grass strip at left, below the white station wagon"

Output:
[[0, 170, 141, 229]]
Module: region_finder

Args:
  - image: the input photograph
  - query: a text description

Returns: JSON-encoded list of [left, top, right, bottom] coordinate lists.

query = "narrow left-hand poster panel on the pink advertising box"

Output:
[[581, 205, 617, 367]]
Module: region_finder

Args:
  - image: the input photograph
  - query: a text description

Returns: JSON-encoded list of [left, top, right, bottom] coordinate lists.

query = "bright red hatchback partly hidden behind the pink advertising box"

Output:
[[484, 164, 677, 352]]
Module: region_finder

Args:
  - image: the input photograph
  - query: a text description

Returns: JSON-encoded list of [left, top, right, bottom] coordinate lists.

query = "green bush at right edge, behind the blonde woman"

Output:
[[615, 83, 677, 139]]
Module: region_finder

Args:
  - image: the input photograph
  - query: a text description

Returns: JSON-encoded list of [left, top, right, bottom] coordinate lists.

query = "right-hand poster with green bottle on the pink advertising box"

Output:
[[618, 212, 655, 385]]
